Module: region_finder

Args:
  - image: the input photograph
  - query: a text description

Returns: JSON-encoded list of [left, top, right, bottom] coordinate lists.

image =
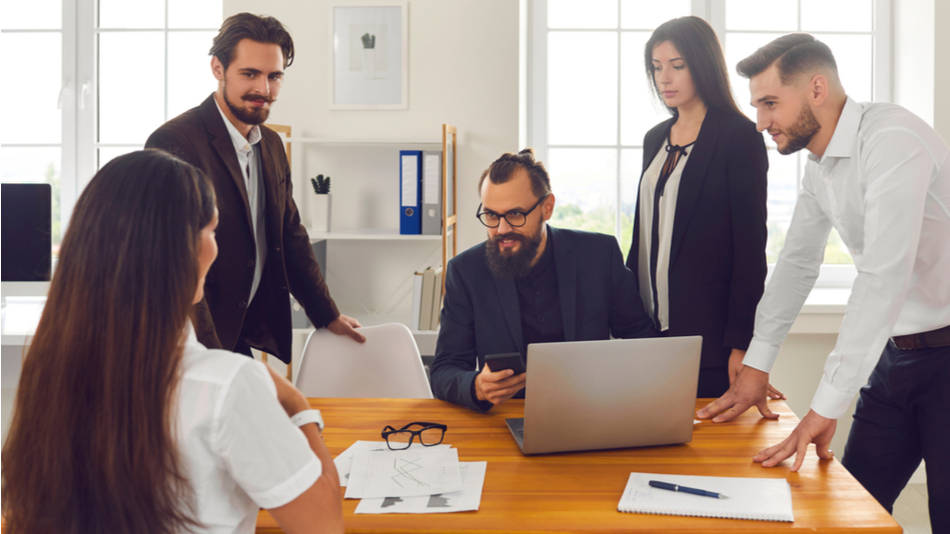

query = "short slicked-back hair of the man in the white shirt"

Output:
[[736, 33, 838, 84]]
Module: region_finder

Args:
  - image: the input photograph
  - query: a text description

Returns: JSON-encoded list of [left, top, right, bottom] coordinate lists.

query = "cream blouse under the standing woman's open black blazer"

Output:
[[637, 139, 695, 332]]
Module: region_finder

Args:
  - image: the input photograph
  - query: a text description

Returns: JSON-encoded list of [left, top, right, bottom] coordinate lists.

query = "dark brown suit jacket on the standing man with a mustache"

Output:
[[145, 95, 340, 362]]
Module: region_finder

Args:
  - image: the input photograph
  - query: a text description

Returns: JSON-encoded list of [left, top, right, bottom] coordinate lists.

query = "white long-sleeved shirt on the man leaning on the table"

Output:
[[743, 98, 950, 418]]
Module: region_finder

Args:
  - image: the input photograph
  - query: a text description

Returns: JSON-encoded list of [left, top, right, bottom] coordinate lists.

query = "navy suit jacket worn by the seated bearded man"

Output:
[[431, 227, 656, 410]]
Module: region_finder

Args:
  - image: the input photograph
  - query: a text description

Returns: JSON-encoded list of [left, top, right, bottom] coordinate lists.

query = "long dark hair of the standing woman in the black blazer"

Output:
[[643, 16, 740, 116]]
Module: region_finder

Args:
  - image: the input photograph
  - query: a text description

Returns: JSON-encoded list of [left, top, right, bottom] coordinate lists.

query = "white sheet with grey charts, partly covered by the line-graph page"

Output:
[[356, 462, 488, 514]]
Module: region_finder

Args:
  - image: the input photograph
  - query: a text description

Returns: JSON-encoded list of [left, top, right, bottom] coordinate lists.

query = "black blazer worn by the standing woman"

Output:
[[627, 109, 769, 396]]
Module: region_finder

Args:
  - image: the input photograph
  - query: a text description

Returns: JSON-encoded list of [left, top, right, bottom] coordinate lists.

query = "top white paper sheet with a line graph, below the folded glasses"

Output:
[[345, 447, 462, 499]]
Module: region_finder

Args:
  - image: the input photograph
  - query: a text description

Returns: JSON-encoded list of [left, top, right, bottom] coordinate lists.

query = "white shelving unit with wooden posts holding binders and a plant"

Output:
[[269, 125, 458, 354]]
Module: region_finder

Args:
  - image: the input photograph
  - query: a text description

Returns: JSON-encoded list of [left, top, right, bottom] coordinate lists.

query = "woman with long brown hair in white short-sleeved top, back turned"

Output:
[[3, 150, 342, 533]]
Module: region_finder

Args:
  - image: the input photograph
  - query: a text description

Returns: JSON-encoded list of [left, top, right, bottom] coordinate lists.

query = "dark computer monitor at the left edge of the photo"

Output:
[[0, 184, 52, 282]]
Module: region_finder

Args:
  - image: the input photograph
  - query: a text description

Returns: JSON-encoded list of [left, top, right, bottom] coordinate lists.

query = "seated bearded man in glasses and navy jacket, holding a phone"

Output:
[[431, 149, 656, 411]]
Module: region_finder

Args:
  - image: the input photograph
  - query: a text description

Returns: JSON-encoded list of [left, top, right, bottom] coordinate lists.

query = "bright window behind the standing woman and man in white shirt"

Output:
[[528, 0, 890, 284]]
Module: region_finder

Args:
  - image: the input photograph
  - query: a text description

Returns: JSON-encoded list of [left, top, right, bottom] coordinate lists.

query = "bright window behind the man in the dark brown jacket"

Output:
[[0, 0, 222, 249]]
